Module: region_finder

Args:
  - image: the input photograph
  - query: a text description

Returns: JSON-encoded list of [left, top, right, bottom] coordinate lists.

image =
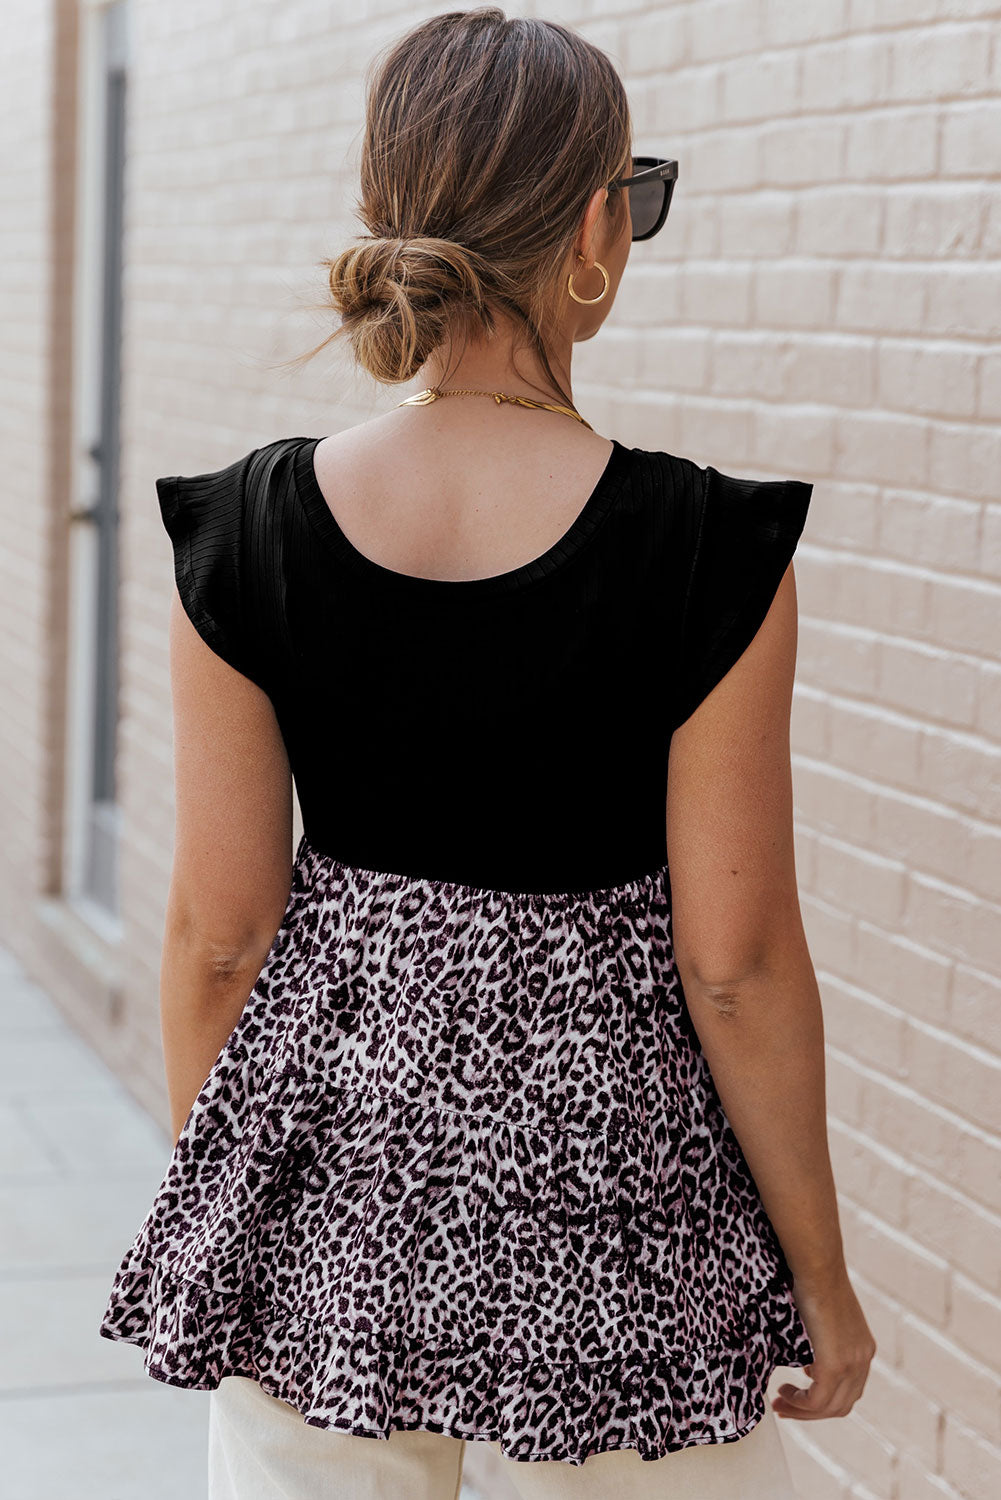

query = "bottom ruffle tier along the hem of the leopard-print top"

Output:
[[102, 1253, 812, 1464]]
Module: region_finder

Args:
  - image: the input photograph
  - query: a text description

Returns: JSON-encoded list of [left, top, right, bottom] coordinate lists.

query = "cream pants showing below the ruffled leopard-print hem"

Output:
[[209, 1376, 795, 1500]]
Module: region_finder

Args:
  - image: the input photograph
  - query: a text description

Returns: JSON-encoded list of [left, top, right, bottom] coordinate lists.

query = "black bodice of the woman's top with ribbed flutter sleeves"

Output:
[[156, 437, 813, 891]]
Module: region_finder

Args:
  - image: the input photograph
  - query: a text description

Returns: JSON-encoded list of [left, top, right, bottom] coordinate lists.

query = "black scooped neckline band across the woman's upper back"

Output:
[[293, 438, 633, 600]]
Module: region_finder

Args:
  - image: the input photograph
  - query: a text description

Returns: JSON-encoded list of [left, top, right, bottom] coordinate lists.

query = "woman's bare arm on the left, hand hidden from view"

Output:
[[161, 590, 293, 1140]]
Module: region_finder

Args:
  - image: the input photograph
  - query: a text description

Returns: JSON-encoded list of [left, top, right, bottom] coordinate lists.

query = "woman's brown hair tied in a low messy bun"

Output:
[[289, 6, 632, 401]]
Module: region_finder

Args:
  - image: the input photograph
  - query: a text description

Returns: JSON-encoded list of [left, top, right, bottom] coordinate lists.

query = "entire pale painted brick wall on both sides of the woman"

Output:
[[0, 0, 1001, 1500]]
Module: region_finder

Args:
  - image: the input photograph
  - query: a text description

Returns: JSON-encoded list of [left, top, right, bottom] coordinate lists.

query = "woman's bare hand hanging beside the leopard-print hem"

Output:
[[771, 1271, 876, 1421]]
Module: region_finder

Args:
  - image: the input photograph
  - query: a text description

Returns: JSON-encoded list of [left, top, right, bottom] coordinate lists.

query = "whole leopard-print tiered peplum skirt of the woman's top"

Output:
[[99, 836, 813, 1464]]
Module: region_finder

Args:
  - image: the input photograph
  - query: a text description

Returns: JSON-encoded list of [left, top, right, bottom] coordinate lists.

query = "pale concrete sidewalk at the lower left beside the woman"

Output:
[[0, 950, 477, 1500]]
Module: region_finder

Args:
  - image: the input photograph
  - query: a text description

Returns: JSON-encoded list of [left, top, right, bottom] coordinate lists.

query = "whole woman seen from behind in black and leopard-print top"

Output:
[[102, 6, 875, 1500]]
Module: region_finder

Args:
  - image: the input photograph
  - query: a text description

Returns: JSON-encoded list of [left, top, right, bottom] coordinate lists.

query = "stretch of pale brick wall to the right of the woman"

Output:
[[603, 0, 1001, 1500]]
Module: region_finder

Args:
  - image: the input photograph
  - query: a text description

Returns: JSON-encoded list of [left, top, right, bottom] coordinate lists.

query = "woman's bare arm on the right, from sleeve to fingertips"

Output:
[[666, 564, 876, 1418]]
